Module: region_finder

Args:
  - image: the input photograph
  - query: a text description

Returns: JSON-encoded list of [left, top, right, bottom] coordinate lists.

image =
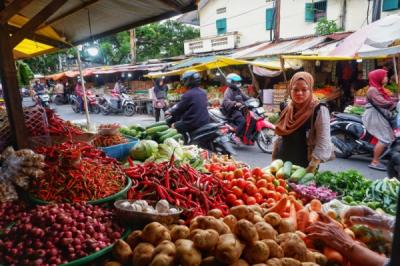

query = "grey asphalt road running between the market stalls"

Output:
[[54, 105, 386, 179]]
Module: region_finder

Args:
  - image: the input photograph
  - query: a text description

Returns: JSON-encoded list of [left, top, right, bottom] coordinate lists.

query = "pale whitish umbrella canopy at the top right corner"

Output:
[[329, 14, 400, 58]]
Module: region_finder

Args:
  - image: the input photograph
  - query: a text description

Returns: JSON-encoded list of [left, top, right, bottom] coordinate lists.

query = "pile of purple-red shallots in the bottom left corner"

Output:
[[0, 203, 122, 265]]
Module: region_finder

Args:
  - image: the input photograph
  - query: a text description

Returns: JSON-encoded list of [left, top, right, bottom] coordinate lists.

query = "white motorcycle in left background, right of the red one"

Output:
[[99, 89, 135, 116]]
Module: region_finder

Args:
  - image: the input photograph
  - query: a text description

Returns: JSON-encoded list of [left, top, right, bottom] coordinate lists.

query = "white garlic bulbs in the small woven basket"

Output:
[[119, 200, 179, 214]]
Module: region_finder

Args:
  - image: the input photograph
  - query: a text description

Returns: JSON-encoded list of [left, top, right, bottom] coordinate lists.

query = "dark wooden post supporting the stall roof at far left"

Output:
[[0, 0, 28, 149]]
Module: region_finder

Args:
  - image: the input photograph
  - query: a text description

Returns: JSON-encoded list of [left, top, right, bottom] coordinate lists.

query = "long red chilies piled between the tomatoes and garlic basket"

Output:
[[125, 158, 230, 222]]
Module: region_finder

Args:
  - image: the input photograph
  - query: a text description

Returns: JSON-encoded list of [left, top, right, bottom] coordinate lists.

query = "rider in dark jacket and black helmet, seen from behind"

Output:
[[167, 71, 209, 134]]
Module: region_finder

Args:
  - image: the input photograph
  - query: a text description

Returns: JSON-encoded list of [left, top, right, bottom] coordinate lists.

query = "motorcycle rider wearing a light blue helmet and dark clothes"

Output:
[[222, 73, 249, 138]]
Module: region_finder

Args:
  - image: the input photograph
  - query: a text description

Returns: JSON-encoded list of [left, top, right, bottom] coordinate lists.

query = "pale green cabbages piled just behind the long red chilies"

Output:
[[130, 138, 204, 170]]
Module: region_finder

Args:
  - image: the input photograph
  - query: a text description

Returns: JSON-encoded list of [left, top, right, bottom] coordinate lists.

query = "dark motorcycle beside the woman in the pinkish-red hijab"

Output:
[[330, 113, 400, 178]]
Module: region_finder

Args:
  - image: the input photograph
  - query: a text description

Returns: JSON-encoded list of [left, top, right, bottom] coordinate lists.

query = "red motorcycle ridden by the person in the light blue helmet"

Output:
[[208, 98, 275, 153]]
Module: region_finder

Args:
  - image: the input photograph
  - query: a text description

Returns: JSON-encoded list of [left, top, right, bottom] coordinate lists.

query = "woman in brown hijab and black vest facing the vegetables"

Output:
[[272, 72, 332, 173]]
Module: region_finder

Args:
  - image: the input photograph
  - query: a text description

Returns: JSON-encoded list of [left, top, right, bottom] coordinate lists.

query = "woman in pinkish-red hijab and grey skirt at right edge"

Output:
[[362, 69, 396, 171]]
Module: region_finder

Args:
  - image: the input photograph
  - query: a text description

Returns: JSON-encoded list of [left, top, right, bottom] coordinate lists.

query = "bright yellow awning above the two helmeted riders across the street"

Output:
[[145, 56, 286, 78]]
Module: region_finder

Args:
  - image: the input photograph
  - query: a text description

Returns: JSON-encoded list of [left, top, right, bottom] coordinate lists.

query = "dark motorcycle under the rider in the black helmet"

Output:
[[165, 104, 236, 157]]
